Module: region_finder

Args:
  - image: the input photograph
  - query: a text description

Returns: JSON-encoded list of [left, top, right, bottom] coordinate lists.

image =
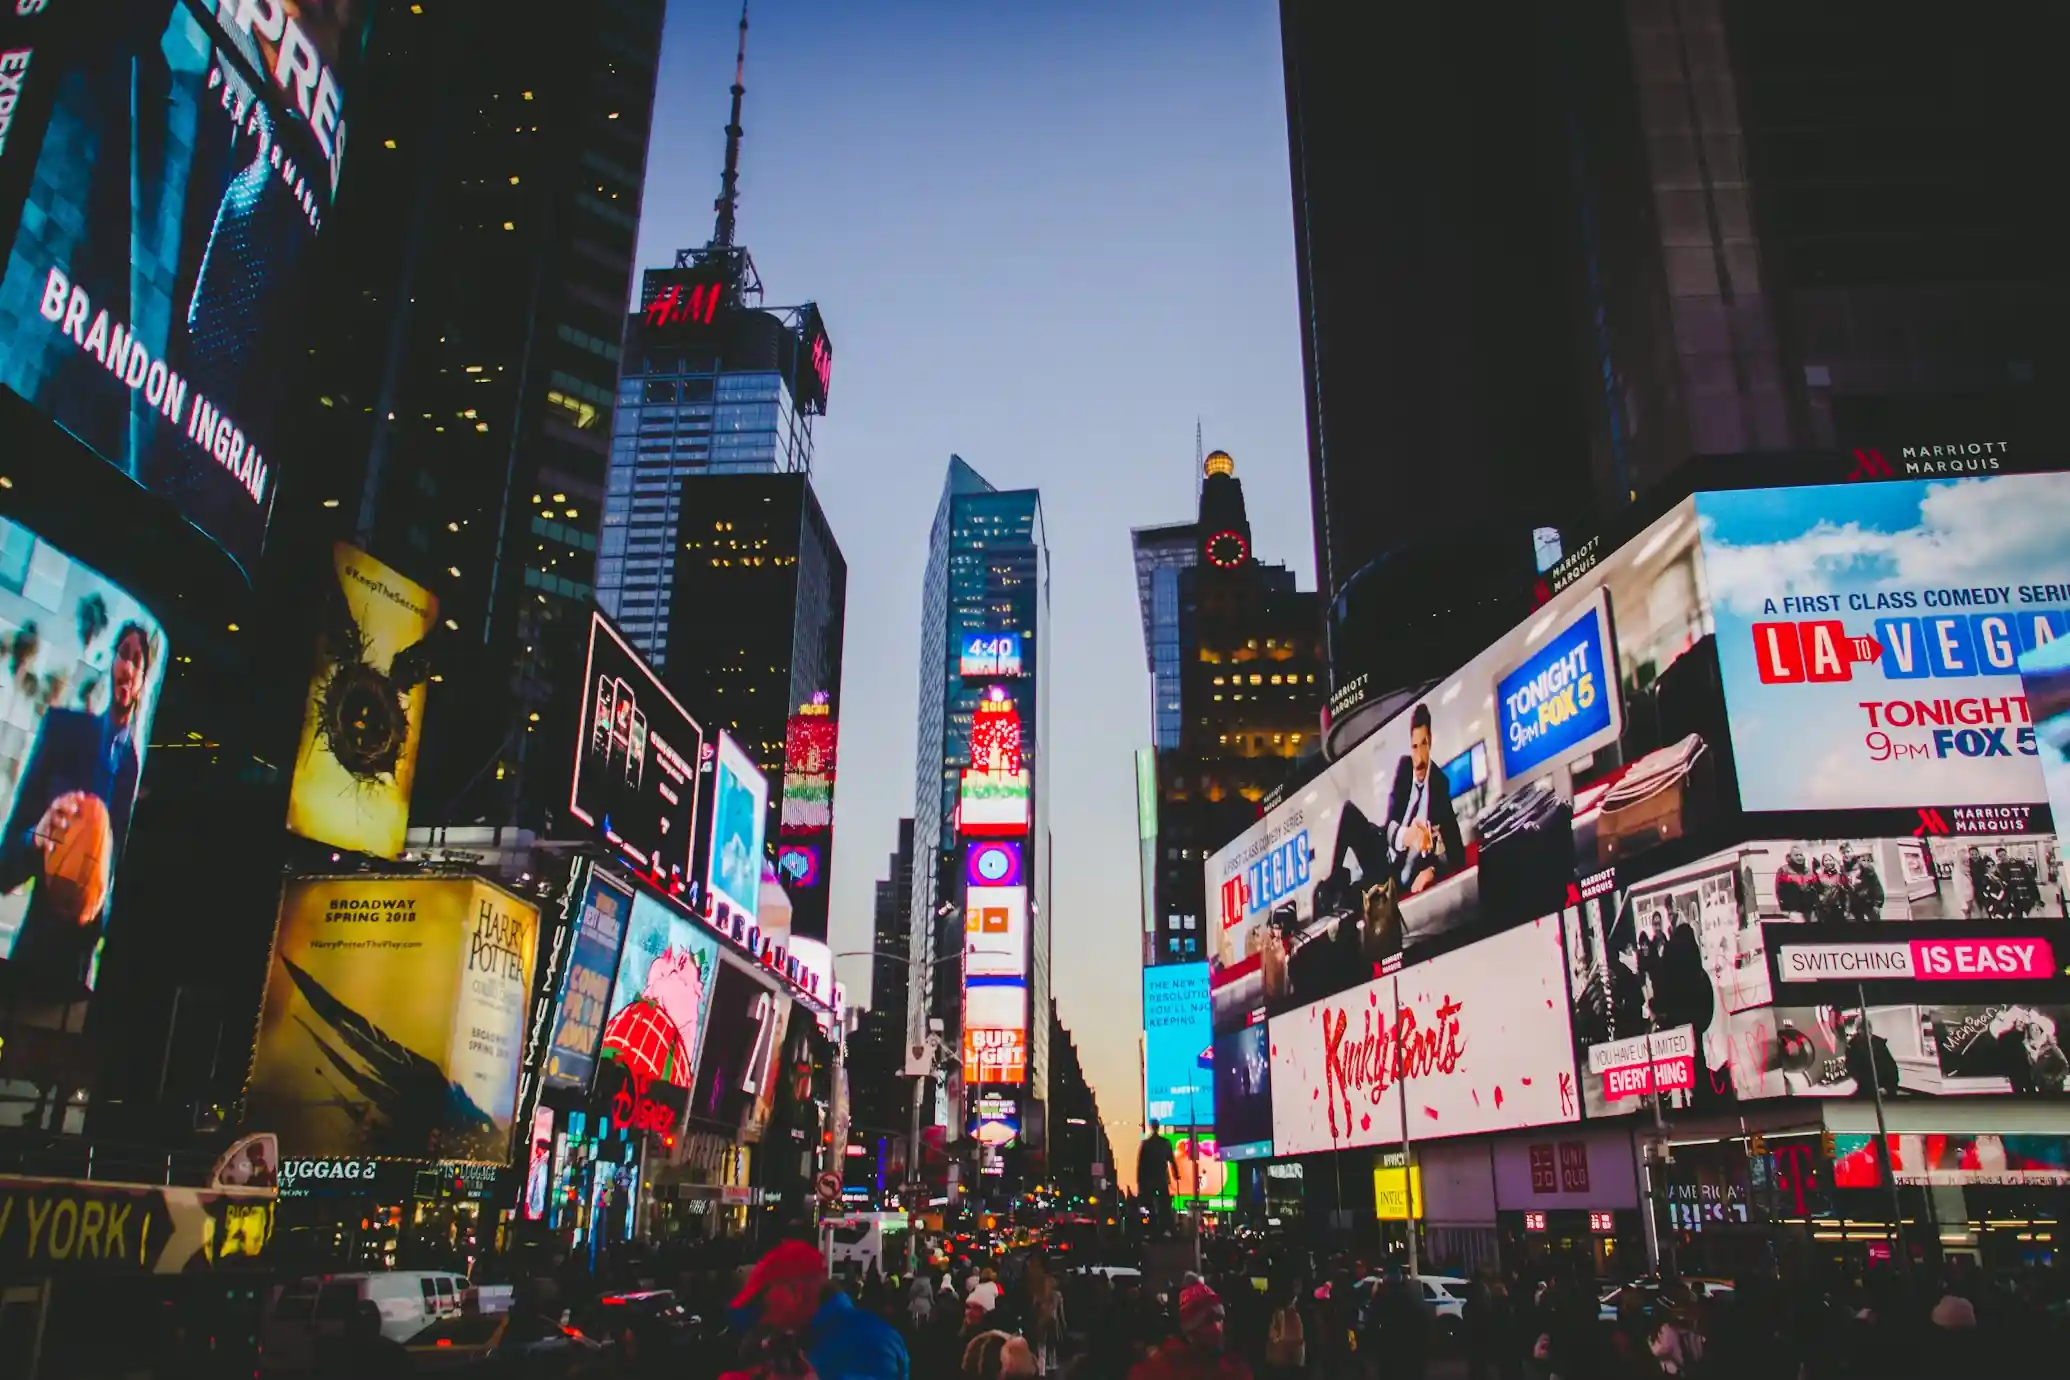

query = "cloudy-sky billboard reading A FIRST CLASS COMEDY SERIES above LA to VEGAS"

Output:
[[1695, 474, 2070, 811]]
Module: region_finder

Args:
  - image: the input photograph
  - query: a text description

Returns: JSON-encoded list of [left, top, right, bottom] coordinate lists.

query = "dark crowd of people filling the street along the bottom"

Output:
[[699, 1243, 2070, 1380]]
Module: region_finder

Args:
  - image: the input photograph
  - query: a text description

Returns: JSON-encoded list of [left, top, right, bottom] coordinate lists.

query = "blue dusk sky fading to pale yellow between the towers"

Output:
[[640, 0, 1314, 1169]]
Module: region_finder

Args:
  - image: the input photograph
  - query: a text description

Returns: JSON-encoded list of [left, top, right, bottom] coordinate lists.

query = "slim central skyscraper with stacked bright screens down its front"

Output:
[[907, 455, 1049, 1166]]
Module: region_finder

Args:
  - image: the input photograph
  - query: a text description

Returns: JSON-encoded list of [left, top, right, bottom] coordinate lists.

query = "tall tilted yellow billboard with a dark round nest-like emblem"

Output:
[[288, 542, 439, 859]]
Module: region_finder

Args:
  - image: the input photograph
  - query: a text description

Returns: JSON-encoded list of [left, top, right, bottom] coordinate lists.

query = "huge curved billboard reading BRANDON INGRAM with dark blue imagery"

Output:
[[0, 0, 368, 571]]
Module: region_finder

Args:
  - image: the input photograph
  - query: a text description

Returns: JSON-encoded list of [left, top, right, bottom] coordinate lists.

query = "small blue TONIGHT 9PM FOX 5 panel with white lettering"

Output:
[[1495, 592, 1619, 780]]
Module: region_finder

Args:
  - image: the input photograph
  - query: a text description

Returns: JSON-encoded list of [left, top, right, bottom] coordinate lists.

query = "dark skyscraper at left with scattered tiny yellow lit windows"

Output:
[[269, 0, 664, 828]]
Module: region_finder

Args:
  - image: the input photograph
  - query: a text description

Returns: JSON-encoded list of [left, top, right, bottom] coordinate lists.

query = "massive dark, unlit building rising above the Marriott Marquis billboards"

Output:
[[1279, 0, 2064, 616]]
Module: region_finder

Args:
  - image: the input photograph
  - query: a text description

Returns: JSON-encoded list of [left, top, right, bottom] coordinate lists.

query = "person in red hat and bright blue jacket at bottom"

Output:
[[729, 1241, 911, 1380]]
